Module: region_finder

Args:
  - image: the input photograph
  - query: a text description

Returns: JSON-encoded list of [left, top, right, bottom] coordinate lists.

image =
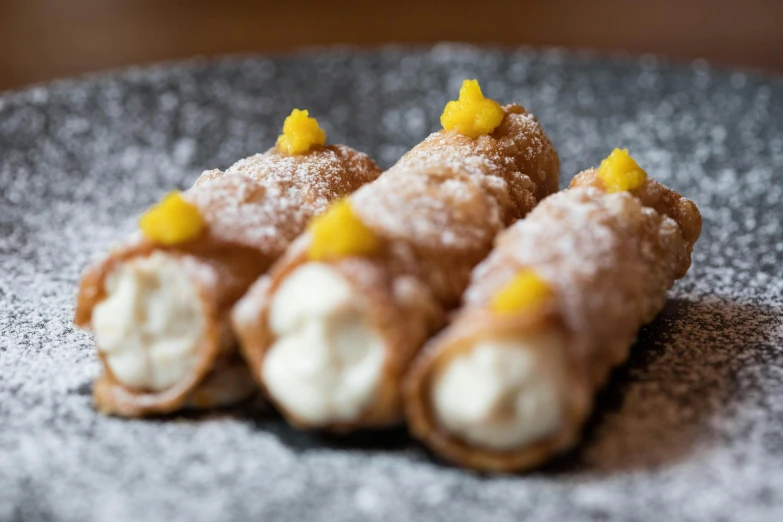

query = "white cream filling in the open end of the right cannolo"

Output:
[[431, 334, 565, 451]]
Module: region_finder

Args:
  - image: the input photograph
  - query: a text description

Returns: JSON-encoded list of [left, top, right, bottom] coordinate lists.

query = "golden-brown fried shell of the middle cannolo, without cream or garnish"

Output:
[[233, 105, 559, 431]]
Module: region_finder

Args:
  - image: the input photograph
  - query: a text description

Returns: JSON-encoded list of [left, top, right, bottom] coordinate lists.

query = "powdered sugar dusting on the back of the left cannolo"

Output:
[[188, 145, 380, 254]]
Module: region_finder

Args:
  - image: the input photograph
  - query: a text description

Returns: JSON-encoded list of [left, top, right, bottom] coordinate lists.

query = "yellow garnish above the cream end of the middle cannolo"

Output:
[[307, 200, 378, 261]]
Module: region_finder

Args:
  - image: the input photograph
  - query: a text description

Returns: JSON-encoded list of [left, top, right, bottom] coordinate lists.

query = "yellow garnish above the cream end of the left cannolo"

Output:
[[139, 191, 205, 246]]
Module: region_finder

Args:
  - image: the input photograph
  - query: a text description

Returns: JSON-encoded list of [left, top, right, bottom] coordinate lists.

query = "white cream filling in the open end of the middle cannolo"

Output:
[[261, 263, 386, 425]]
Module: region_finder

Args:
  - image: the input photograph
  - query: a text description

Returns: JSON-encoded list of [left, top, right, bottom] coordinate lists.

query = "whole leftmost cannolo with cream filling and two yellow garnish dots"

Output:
[[75, 110, 380, 417]]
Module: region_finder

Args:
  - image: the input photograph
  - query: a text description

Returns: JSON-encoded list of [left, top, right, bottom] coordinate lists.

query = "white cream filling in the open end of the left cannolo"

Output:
[[92, 252, 205, 391]]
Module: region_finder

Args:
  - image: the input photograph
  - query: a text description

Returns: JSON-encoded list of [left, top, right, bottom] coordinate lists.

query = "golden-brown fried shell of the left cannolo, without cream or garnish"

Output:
[[74, 145, 380, 417]]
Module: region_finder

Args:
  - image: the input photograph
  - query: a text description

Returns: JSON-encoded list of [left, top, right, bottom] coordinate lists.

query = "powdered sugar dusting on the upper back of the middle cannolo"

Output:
[[353, 106, 559, 255]]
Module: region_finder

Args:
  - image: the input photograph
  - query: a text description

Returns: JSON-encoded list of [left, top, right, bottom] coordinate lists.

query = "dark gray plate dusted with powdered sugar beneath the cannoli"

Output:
[[0, 46, 783, 522]]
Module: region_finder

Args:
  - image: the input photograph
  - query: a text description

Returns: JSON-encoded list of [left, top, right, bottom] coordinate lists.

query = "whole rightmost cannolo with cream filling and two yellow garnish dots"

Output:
[[404, 150, 701, 472]]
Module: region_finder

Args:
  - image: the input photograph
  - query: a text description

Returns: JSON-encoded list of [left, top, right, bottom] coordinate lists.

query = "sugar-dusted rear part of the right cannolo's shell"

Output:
[[465, 188, 689, 371]]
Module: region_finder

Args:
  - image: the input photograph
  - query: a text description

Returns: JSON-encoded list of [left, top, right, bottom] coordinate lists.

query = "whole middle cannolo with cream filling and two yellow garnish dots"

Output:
[[232, 80, 559, 432]]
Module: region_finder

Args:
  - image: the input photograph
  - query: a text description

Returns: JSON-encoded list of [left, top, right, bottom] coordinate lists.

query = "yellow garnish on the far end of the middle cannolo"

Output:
[[440, 80, 506, 138]]
